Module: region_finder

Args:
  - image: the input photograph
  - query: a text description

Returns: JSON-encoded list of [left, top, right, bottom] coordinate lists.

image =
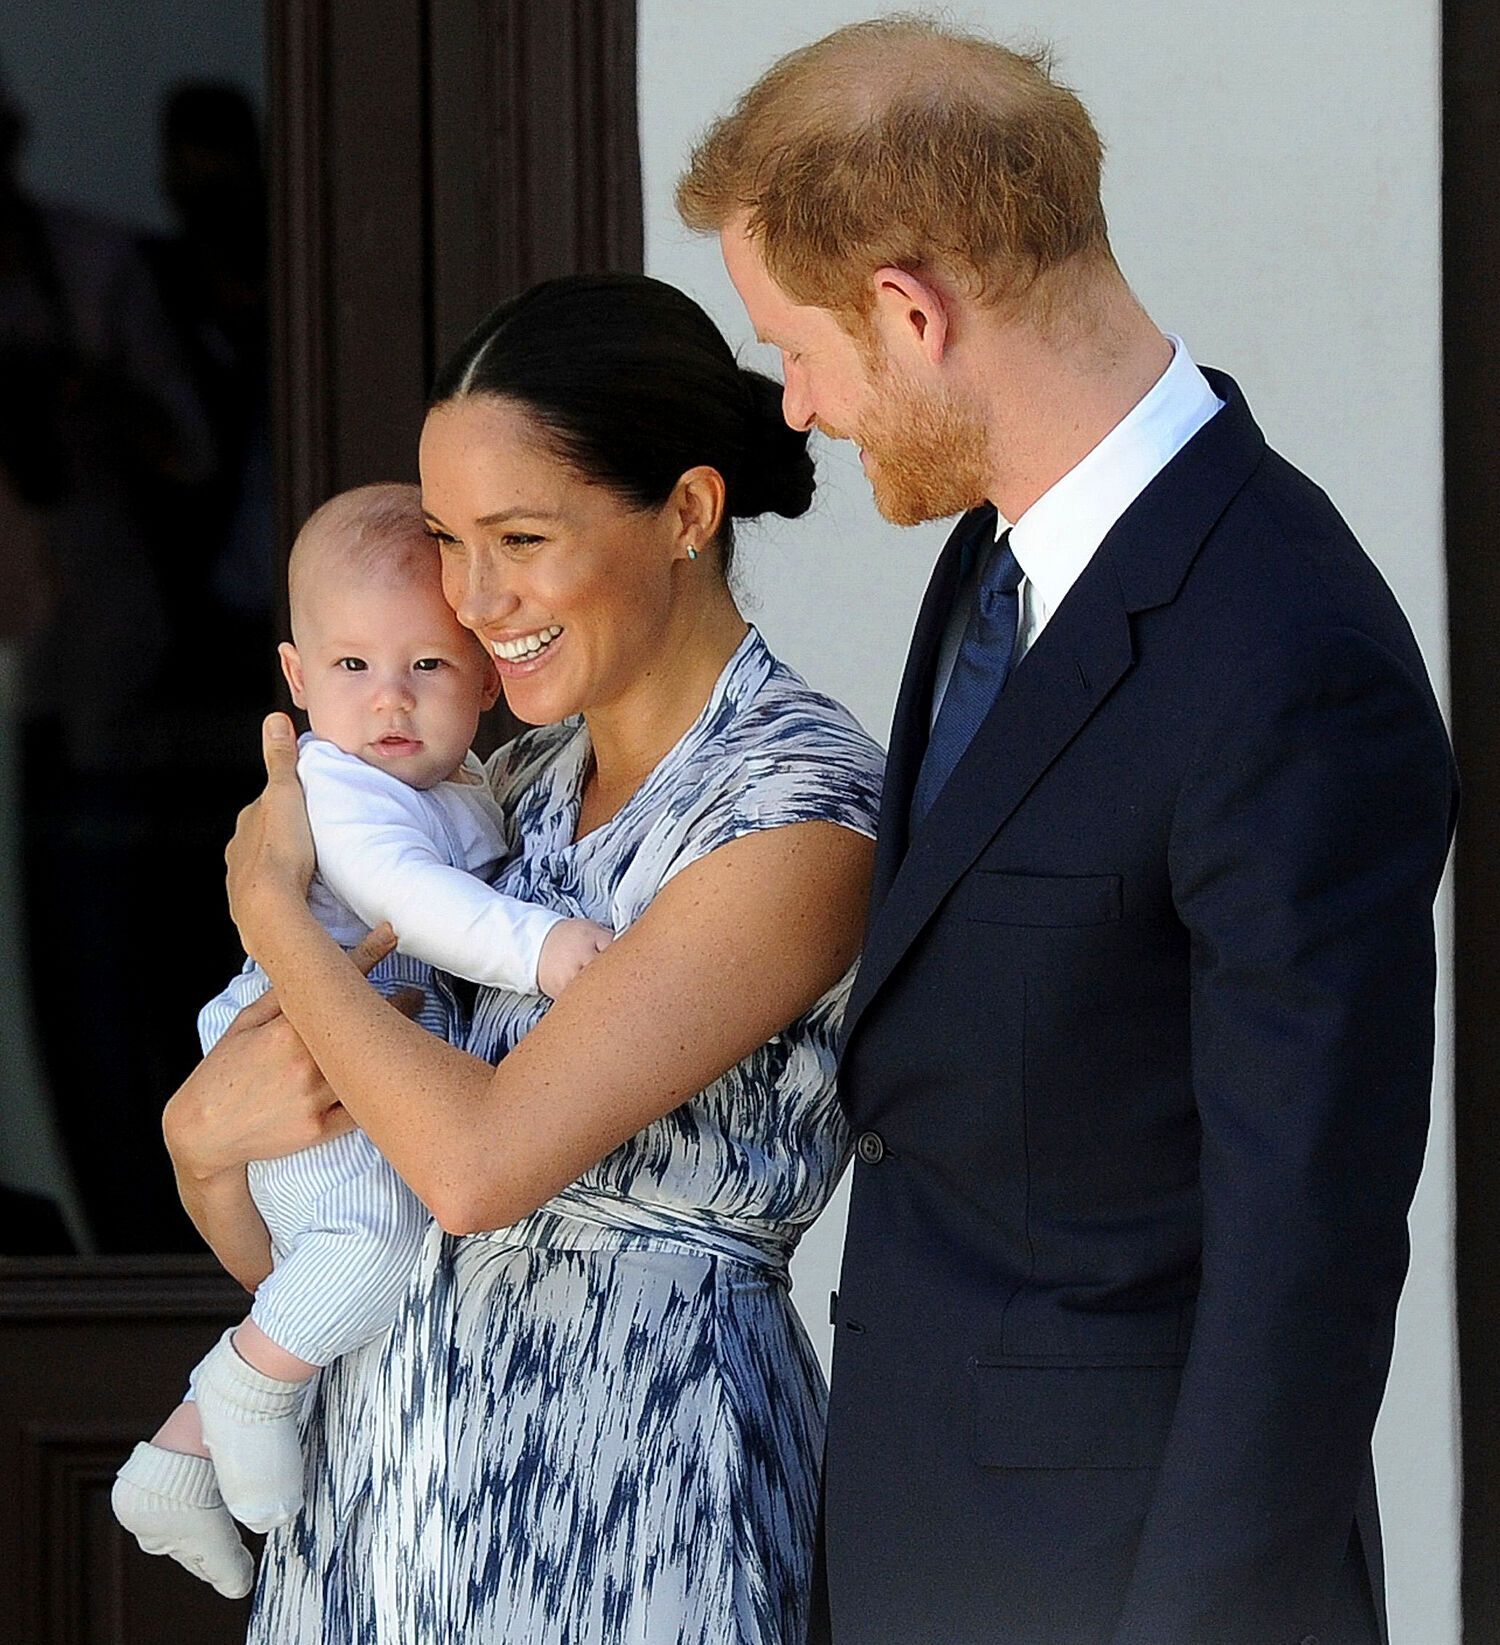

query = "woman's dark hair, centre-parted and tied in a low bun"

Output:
[[429, 275, 813, 571]]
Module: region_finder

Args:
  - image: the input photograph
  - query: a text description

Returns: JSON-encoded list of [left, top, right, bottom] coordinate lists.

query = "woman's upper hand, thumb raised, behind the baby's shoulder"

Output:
[[224, 714, 316, 959]]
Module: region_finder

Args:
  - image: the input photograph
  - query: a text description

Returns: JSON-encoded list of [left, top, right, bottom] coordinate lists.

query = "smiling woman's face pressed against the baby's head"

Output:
[[419, 395, 674, 725]]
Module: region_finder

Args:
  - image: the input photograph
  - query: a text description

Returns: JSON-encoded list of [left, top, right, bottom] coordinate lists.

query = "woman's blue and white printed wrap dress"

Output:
[[250, 628, 882, 1645]]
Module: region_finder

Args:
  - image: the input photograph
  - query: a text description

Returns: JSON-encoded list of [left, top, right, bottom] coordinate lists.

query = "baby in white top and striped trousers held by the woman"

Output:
[[112, 485, 610, 1599]]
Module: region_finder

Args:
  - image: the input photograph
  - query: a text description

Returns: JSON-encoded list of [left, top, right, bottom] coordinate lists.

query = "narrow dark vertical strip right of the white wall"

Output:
[[1442, 0, 1500, 1645]]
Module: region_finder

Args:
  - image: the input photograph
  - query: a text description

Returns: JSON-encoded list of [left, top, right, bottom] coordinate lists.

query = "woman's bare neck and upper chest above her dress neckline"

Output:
[[577, 591, 748, 836]]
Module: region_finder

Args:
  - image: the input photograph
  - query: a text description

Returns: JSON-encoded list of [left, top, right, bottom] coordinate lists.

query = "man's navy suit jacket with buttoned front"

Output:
[[813, 373, 1456, 1645]]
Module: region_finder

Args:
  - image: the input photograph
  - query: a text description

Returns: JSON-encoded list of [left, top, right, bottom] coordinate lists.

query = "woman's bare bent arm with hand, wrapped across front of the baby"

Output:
[[229, 717, 873, 1232]]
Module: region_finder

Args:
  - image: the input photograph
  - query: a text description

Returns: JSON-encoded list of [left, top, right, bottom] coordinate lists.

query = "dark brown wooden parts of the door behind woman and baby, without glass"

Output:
[[0, 0, 641, 1645]]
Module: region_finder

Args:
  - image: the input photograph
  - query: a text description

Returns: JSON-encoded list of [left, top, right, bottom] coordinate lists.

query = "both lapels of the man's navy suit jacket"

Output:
[[842, 372, 1265, 1048]]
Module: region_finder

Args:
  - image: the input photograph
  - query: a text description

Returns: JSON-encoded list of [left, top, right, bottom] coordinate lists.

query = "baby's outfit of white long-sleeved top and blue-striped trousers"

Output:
[[197, 735, 563, 1365]]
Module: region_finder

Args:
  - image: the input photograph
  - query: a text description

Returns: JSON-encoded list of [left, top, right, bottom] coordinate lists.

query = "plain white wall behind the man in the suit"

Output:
[[640, 0, 1459, 1645]]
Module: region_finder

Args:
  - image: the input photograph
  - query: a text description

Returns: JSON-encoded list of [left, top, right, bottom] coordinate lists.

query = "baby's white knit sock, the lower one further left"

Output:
[[110, 1444, 255, 1599]]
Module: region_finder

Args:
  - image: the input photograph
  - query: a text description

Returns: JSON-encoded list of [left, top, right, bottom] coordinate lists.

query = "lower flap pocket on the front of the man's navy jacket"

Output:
[[974, 1365, 1183, 1467]]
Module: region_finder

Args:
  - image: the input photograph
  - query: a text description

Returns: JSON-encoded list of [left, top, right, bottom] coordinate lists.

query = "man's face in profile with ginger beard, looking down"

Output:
[[720, 220, 985, 525]]
